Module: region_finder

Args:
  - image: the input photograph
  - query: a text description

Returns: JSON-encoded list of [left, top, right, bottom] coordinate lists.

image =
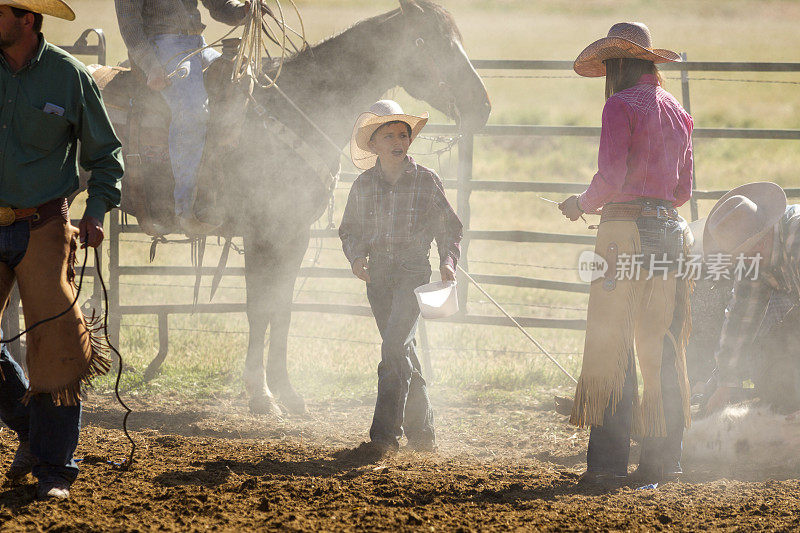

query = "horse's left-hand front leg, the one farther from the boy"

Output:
[[242, 235, 281, 415]]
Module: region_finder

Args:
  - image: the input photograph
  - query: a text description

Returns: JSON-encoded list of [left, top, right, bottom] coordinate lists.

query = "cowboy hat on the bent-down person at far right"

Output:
[[703, 181, 786, 255]]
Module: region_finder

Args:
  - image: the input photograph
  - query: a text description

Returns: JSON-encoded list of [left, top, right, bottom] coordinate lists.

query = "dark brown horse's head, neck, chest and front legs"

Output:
[[113, 0, 491, 413]]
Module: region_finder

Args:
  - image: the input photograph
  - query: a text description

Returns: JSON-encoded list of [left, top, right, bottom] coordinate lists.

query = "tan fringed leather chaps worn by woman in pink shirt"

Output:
[[570, 221, 691, 437]]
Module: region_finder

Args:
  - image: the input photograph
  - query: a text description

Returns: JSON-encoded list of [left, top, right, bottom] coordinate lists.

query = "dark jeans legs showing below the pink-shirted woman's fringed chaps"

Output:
[[586, 338, 684, 476]]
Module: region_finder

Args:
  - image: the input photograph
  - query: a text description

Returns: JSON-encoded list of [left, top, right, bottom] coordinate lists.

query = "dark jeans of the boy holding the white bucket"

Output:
[[367, 256, 435, 447]]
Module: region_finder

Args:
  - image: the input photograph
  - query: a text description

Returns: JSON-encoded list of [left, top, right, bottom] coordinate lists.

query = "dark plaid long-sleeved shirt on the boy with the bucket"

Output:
[[339, 157, 463, 268]]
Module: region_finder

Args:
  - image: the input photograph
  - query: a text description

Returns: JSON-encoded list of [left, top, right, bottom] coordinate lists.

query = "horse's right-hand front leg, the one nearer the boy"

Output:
[[267, 230, 309, 414]]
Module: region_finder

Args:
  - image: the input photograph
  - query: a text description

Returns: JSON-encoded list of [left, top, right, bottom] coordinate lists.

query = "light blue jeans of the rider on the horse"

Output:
[[154, 34, 220, 216]]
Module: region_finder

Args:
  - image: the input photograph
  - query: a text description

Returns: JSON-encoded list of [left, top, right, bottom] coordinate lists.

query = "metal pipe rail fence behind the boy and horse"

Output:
[[4, 30, 800, 375]]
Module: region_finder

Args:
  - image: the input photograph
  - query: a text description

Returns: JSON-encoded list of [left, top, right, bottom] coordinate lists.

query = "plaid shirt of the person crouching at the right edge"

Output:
[[716, 205, 800, 386]]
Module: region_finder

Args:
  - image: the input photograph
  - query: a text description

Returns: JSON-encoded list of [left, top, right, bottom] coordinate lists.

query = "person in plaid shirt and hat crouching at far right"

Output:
[[703, 182, 800, 413]]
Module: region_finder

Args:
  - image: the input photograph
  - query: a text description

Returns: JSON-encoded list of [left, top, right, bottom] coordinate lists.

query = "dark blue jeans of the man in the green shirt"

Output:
[[0, 221, 81, 483]]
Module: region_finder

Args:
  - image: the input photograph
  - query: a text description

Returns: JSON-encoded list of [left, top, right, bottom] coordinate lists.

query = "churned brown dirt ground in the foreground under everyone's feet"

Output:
[[0, 395, 800, 531]]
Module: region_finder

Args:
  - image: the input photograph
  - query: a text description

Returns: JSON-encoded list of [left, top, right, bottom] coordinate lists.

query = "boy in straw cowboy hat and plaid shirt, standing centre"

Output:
[[339, 100, 462, 452]]
